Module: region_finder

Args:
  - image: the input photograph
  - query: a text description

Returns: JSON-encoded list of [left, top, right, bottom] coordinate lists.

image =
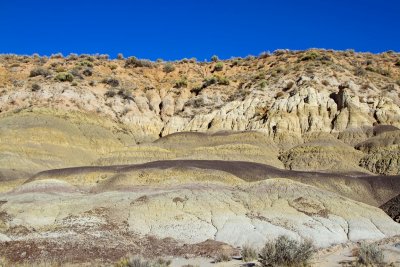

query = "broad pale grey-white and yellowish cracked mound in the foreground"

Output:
[[1, 179, 400, 251]]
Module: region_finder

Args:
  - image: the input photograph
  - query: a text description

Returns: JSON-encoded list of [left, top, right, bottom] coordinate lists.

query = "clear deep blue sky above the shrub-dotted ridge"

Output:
[[0, 0, 400, 60]]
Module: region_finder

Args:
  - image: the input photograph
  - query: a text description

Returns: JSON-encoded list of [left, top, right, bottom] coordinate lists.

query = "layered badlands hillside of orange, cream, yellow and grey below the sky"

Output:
[[0, 49, 400, 266]]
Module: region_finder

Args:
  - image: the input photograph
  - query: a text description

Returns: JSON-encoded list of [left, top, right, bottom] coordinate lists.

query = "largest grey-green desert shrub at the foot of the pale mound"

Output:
[[260, 235, 314, 267]]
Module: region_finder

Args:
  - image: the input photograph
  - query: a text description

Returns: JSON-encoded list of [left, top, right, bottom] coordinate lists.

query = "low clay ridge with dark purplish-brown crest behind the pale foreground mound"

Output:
[[28, 160, 400, 206]]
